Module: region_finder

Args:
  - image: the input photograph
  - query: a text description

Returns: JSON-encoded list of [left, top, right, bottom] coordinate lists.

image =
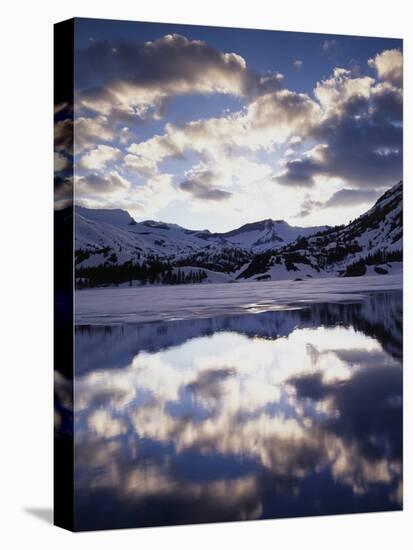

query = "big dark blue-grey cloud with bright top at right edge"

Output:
[[277, 59, 403, 189]]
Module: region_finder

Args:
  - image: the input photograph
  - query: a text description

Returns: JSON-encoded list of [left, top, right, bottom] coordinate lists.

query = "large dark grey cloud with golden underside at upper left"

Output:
[[76, 34, 282, 120]]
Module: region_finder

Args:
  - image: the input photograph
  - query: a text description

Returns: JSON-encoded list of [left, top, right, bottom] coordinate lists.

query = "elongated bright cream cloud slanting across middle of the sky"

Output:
[[125, 90, 320, 170]]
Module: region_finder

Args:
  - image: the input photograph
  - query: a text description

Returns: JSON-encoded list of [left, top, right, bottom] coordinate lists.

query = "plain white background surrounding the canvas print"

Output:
[[0, 0, 413, 550]]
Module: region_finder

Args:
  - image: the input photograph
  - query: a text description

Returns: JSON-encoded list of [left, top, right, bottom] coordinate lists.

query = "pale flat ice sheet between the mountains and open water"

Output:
[[75, 274, 403, 325]]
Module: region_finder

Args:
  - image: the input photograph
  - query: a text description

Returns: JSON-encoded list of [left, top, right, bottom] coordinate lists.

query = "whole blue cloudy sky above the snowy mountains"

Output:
[[55, 19, 403, 231]]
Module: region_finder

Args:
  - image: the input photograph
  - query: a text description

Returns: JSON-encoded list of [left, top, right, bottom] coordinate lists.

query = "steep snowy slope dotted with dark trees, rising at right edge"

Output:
[[238, 182, 403, 280]]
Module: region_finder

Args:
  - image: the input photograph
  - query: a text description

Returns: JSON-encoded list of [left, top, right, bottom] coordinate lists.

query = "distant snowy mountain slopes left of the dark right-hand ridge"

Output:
[[75, 206, 325, 267]]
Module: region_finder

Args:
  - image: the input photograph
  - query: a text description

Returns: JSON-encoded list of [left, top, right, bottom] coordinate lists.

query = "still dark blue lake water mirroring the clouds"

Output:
[[74, 291, 402, 529]]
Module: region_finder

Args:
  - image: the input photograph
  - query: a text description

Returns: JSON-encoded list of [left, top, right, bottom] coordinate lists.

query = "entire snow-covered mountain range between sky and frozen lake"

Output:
[[75, 182, 402, 286]]
